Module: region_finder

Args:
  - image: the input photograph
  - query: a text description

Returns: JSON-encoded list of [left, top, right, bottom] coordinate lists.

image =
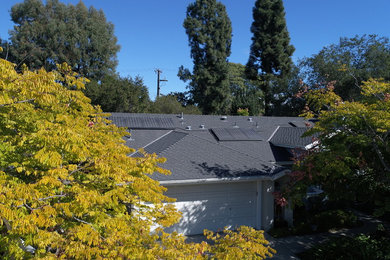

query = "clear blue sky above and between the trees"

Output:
[[0, 0, 390, 99]]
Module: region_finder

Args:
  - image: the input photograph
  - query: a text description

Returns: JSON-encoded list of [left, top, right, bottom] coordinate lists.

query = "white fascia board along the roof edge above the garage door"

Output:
[[160, 170, 290, 186]]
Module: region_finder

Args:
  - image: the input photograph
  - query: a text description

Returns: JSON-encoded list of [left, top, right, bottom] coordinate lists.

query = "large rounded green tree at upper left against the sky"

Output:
[[6, 0, 119, 80]]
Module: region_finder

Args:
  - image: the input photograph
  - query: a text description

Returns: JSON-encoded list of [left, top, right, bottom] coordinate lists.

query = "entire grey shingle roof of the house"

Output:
[[110, 113, 311, 181]]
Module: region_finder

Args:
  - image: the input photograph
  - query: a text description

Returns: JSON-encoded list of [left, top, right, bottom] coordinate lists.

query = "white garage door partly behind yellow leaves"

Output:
[[166, 182, 256, 235]]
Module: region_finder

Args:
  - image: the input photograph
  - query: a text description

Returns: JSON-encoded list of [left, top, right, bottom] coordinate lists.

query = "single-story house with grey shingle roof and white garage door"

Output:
[[110, 113, 312, 235]]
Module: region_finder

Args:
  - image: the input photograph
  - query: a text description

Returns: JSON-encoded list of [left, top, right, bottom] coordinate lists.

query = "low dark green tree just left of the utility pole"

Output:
[[84, 75, 151, 113]]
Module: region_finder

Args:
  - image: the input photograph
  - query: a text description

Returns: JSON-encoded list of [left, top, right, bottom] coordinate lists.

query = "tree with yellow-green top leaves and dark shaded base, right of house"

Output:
[[284, 79, 390, 217]]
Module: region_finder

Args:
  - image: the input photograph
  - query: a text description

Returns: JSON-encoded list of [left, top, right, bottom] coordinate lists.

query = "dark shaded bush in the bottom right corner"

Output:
[[298, 235, 390, 260]]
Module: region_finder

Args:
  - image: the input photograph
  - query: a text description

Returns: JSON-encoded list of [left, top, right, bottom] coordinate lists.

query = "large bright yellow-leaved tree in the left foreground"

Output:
[[0, 54, 275, 259]]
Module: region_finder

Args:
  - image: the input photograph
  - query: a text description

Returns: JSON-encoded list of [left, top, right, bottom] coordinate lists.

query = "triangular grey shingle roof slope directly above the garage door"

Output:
[[153, 132, 284, 181]]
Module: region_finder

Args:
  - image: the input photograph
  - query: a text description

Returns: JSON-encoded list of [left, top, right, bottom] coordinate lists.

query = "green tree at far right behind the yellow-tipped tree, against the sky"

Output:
[[300, 35, 390, 100]]
